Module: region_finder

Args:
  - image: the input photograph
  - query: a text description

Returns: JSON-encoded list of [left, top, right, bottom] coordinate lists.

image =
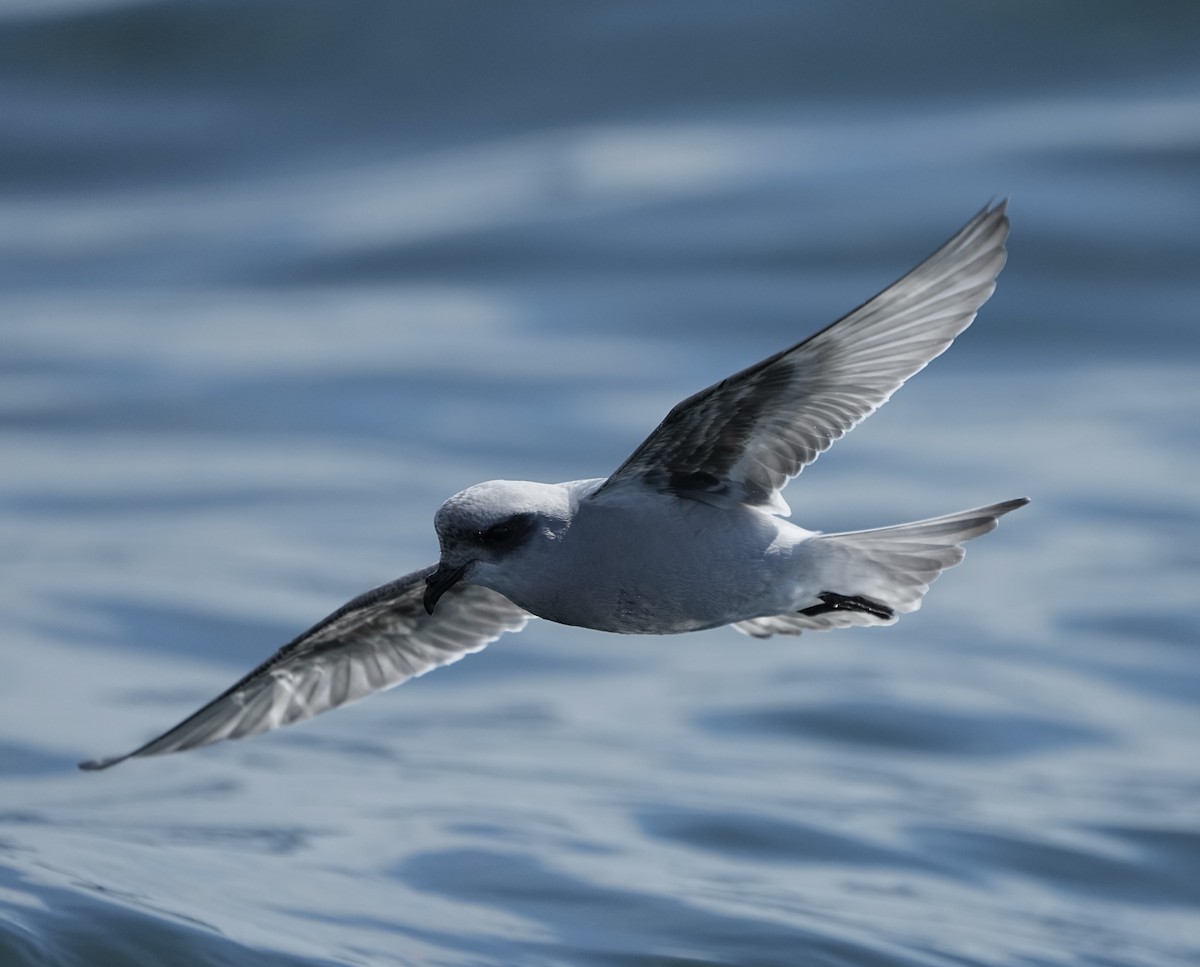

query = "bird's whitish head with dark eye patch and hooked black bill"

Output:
[[425, 480, 571, 614]]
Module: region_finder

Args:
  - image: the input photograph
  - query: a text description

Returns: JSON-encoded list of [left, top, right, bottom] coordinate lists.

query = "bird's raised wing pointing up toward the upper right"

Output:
[[595, 202, 1008, 513]]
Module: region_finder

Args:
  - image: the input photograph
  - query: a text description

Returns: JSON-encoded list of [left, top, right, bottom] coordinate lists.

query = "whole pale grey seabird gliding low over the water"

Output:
[[79, 202, 1028, 770]]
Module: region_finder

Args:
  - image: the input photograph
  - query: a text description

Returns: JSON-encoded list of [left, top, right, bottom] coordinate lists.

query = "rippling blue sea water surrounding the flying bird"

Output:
[[0, 0, 1200, 967]]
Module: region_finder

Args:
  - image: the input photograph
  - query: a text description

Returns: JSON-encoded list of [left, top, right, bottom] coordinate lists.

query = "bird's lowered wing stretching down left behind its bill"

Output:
[[79, 567, 530, 770]]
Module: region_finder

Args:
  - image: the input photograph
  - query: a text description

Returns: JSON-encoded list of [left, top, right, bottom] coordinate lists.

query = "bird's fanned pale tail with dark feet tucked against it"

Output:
[[734, 497, 1030, 637]]
